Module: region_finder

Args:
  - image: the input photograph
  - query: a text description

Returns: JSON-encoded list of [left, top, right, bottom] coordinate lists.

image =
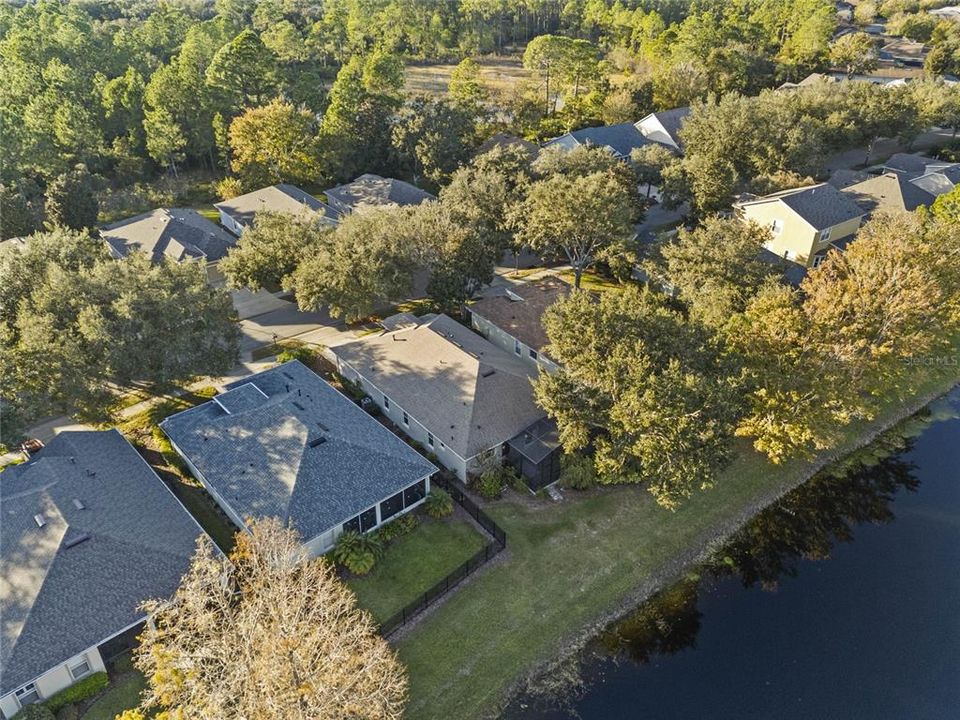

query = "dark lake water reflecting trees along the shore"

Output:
[[504, 392, 960, 720]]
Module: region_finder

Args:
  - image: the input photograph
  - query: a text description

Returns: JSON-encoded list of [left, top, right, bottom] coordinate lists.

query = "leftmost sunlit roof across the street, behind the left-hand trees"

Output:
[[100, 208, 236, 262]]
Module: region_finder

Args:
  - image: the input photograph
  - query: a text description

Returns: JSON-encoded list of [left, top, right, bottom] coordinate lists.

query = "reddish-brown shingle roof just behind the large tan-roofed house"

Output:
[[469, 278, 570, 358]]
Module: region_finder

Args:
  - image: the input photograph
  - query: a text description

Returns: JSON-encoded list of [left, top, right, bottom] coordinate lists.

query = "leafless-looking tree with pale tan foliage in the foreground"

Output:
[[136, 520, 407, 720]]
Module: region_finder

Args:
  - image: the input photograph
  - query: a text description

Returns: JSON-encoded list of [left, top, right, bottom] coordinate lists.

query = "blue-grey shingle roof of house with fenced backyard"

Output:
[[160, 360, 436, 541]]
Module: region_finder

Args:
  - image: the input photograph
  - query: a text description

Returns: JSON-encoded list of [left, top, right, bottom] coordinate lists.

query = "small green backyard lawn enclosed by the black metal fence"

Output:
[[347, 517, 486, 622]]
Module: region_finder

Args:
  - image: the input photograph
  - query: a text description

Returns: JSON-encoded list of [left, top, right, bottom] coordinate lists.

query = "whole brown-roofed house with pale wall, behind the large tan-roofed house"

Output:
[[467, 277, 570, 372]]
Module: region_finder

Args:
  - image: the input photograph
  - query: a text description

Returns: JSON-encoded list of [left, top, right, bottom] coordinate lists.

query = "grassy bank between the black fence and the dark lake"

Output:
[[397, 368, 956, 720]]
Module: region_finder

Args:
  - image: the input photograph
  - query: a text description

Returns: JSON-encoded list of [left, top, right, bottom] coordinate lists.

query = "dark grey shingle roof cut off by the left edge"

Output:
[[0, 430, 203, 695]]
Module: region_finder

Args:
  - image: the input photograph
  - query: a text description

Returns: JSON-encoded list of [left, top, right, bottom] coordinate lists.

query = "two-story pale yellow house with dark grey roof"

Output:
[[735, 183, 866, 267]]
